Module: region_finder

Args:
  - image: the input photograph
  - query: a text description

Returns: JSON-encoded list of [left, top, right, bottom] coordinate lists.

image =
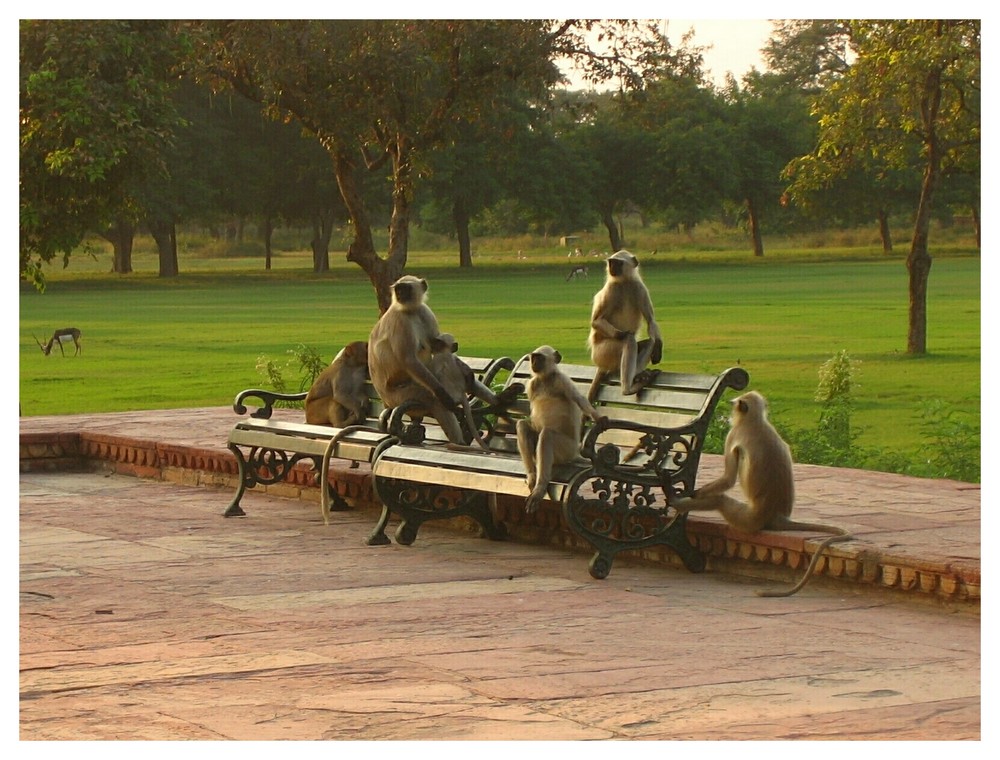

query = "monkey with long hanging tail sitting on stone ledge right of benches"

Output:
[[671, 391, 852, 596]]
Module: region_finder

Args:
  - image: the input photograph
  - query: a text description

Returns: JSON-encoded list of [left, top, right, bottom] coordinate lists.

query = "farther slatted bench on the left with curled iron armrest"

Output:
[[224, 357, 514, 520]]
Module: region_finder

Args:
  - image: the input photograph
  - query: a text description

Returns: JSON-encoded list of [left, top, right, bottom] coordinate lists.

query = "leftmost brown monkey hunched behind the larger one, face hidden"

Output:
[[306, 340, 369, 427]]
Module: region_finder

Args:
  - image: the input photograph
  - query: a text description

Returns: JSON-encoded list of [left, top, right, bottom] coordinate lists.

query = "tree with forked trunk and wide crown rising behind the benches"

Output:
[[192, 20, 660, 310]]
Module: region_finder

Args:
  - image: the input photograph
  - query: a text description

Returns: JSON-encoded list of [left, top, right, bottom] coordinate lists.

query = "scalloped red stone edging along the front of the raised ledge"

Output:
[[20, 432, 981, 607]]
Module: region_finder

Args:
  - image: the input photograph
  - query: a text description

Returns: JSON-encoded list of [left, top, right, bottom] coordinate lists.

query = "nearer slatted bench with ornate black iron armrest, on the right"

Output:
[[368, 356, 750, 579]]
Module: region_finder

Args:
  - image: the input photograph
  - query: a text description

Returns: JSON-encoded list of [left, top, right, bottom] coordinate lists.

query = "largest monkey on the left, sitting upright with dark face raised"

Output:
[[368, 275, 463, 444]]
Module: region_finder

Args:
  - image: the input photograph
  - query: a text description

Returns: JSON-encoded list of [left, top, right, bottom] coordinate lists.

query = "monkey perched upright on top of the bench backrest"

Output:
[[587, 251, 663, 402]]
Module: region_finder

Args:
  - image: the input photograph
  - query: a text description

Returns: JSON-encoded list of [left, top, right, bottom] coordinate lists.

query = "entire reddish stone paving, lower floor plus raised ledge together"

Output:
[[19, 408, 991, 740]]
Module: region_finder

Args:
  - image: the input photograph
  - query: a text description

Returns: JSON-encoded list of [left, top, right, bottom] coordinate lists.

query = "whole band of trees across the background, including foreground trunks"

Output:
[[19, 19, 981, 353]]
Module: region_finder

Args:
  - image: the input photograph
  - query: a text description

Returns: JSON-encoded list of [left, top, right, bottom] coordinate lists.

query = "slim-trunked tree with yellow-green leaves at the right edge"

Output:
[[800, 19, 981, 354]]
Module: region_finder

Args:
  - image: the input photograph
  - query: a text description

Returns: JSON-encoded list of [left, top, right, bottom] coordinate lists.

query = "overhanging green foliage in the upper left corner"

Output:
[[19, 20, 185, 289]]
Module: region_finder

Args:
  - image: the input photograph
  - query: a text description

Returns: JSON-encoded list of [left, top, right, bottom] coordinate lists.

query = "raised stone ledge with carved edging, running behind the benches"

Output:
[[20, 407, 981, 608]]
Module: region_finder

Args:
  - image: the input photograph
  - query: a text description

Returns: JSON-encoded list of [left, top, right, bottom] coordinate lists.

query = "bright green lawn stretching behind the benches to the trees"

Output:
[[19, 243, 981, 472]]
